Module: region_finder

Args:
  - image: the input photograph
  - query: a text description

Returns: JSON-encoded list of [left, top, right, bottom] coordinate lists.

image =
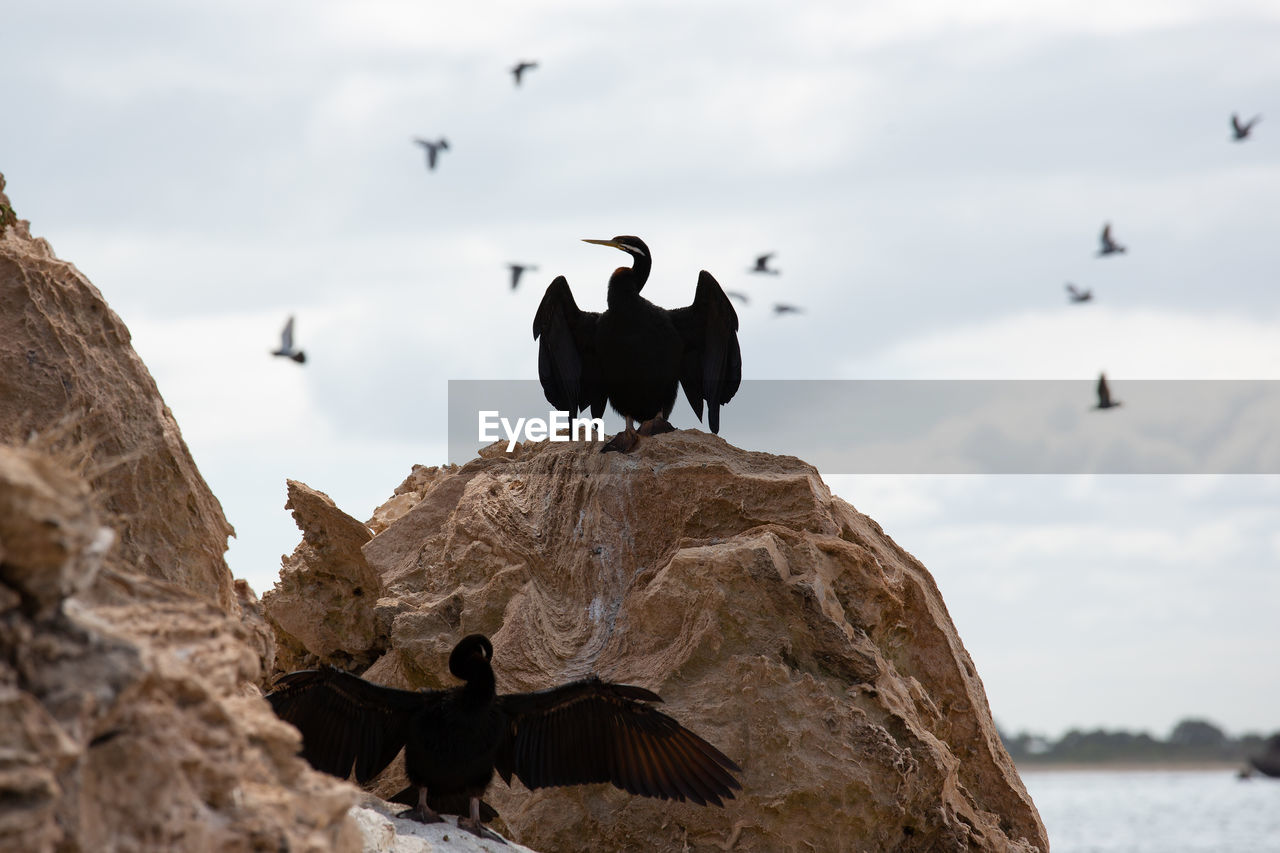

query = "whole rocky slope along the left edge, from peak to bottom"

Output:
[[0, 175, 535, 853]]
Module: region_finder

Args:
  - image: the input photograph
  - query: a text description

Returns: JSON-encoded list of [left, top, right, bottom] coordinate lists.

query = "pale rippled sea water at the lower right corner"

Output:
[[1020, 770, 1280, 853]]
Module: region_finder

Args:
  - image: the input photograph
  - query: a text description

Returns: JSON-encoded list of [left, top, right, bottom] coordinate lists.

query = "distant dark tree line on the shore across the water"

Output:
[[1000, 720, 1267, 765]]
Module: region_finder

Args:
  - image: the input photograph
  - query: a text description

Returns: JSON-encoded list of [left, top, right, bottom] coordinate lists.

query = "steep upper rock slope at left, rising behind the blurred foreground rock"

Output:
[[0, 175, 236, 611]]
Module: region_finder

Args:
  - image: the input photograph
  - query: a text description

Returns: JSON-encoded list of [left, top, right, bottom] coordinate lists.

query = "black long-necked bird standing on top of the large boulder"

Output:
[[534, 236, 742, 452]]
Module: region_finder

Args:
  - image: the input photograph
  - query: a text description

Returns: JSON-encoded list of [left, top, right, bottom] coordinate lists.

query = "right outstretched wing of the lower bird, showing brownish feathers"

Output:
[[494, 678, 742, 806]]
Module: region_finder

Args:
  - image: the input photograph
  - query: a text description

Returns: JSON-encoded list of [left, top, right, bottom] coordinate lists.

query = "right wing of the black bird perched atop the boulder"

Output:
[[671, 270, 742, 433]]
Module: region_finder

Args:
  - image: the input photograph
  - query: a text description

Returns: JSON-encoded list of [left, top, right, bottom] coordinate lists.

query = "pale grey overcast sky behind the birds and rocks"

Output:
[[0, 0, 1280, 734]]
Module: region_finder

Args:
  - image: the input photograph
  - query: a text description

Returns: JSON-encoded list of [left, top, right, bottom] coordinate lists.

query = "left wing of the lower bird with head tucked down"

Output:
[[266, 670, 433, 785]]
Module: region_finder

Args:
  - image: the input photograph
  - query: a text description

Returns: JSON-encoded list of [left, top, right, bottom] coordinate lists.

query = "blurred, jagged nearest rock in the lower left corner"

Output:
[[0, 446, 360, 852]]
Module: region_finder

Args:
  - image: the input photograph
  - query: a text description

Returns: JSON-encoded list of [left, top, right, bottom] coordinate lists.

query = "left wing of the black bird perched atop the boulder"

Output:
[[534, 275, 608, 418]]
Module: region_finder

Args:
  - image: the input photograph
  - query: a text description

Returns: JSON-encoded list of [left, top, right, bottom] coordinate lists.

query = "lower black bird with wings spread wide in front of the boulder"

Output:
[[266, 634, 742, 840]]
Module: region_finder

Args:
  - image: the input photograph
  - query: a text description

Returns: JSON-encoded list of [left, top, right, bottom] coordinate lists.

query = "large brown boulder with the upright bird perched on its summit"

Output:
[[265, 432, 1048, 852]]
